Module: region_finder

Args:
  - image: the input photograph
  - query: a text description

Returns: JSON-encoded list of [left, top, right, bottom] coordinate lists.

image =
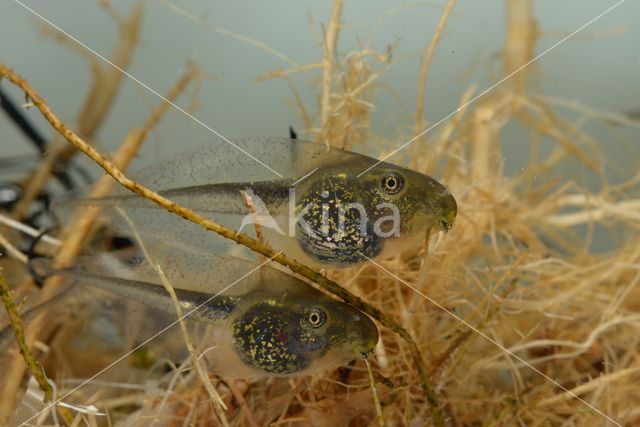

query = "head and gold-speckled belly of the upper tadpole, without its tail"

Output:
[[288, 163, 457, 267]]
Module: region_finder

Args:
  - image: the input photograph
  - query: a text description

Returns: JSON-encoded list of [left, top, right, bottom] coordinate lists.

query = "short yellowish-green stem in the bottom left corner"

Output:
[[0, 268, 73, 424]]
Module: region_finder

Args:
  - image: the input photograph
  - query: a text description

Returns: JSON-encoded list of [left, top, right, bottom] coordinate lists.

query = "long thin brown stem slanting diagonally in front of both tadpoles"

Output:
[[0, 63, 444, 426]]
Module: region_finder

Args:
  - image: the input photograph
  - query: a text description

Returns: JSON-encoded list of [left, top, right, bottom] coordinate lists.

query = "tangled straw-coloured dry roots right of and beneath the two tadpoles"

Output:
[[0, 0, 640, 426]]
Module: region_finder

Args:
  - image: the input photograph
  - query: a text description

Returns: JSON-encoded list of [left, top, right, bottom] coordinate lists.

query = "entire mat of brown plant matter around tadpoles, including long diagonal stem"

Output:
[[0, 0, 640, 426]]
